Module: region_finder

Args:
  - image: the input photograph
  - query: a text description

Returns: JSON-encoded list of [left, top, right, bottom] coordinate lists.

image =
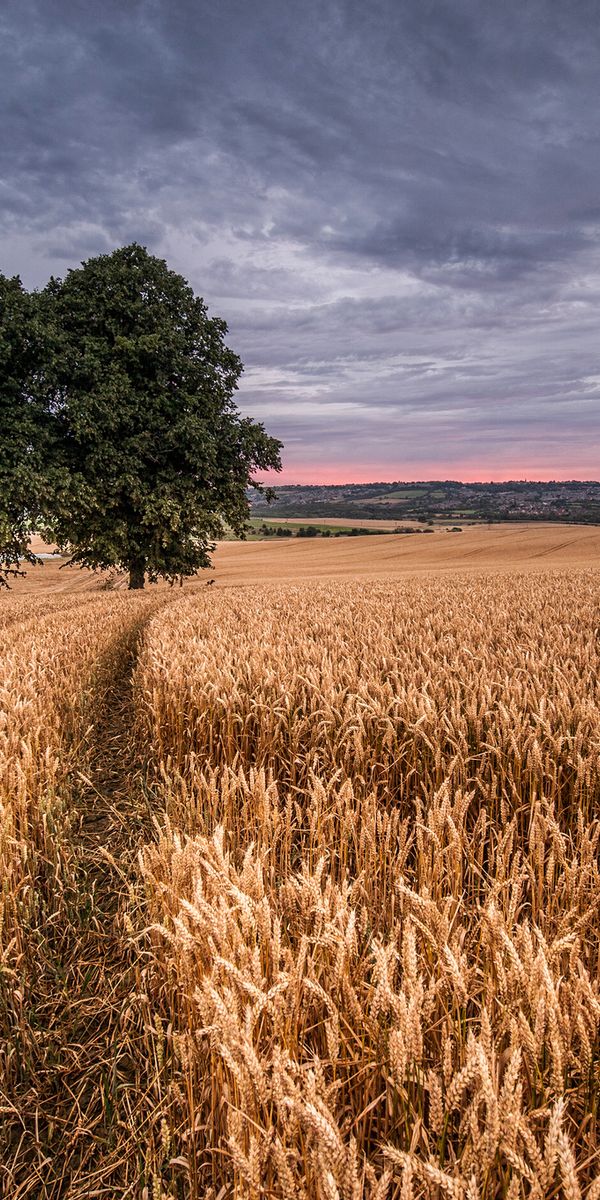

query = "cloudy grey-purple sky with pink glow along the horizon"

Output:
[[0, 0, 600, 482]]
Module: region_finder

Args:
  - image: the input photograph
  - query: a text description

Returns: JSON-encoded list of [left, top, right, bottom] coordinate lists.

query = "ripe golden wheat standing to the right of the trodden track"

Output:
[[136, 571, 600, 1200]]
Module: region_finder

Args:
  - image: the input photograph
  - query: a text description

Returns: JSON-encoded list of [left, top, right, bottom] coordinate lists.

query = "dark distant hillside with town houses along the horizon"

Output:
[[250, 480, 600, 524]]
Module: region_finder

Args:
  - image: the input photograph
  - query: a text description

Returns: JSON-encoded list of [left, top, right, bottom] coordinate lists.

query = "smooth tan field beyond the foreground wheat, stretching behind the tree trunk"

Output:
[[10, 522, 600, 590]]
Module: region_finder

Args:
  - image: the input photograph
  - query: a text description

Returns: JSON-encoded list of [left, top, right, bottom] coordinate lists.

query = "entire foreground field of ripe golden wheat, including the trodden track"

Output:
[[0, 569, 600, 1200]]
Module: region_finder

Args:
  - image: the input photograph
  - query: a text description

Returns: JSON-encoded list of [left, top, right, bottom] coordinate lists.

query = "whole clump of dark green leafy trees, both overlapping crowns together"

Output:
[[0, 244, 281, 588]]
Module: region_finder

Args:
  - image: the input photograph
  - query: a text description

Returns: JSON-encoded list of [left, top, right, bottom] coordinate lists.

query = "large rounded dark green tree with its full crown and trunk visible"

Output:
[[41, 244, 281, 588]]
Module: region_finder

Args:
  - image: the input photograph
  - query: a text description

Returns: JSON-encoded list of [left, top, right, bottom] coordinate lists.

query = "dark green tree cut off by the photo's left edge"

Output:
[[0, 275, 54, 586]]
